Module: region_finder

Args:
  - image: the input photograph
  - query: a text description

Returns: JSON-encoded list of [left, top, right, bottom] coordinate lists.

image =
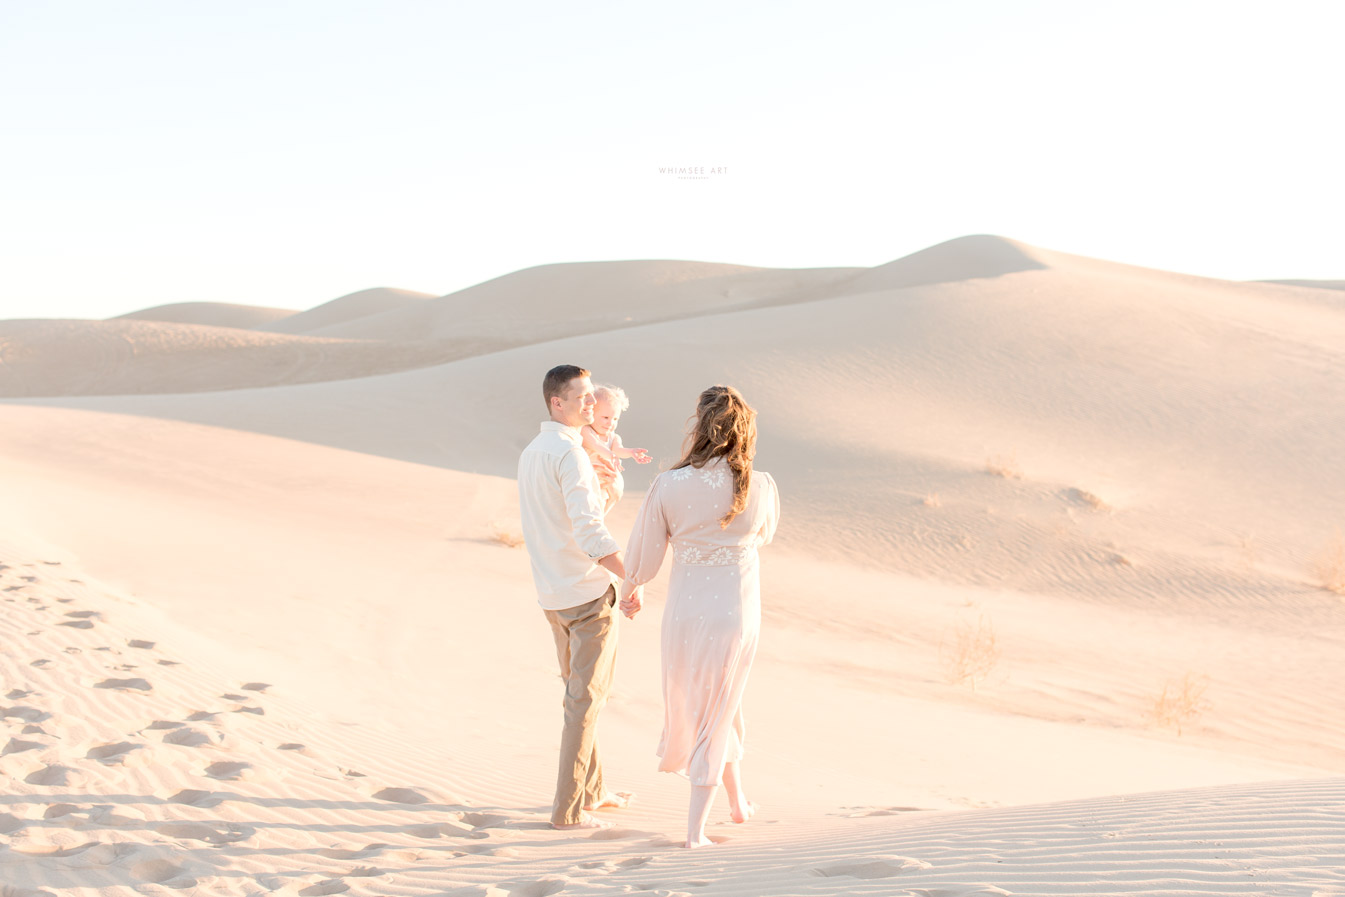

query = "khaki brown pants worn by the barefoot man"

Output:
[[546, 586, 616, 826]]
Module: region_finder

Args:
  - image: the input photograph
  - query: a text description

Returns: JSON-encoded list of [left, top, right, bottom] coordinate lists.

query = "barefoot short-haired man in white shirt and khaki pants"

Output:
[[518, 364, 642, 828]]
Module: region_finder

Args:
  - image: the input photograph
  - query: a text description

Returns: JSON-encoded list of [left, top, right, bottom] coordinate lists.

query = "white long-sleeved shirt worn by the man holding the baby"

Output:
[[518, 421, 621, 611]]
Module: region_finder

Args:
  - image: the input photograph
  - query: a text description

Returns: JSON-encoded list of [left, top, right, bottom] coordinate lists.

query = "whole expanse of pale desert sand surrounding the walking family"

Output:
[[0, 237, 1345, 897]]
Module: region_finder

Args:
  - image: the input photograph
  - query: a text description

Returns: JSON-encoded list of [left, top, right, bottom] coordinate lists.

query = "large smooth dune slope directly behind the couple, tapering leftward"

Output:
[[13, 238, 1345, 615]]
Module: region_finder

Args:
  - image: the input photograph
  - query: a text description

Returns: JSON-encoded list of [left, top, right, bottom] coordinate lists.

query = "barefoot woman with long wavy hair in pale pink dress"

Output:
[[621, 386, 780, 847]]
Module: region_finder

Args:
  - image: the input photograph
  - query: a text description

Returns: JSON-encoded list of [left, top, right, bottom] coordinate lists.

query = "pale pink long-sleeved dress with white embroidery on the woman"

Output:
[[625, 459, 780, 785]]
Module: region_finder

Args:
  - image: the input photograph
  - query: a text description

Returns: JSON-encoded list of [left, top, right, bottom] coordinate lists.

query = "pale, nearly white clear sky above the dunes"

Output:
[[0, 0, 1345, 319]]
